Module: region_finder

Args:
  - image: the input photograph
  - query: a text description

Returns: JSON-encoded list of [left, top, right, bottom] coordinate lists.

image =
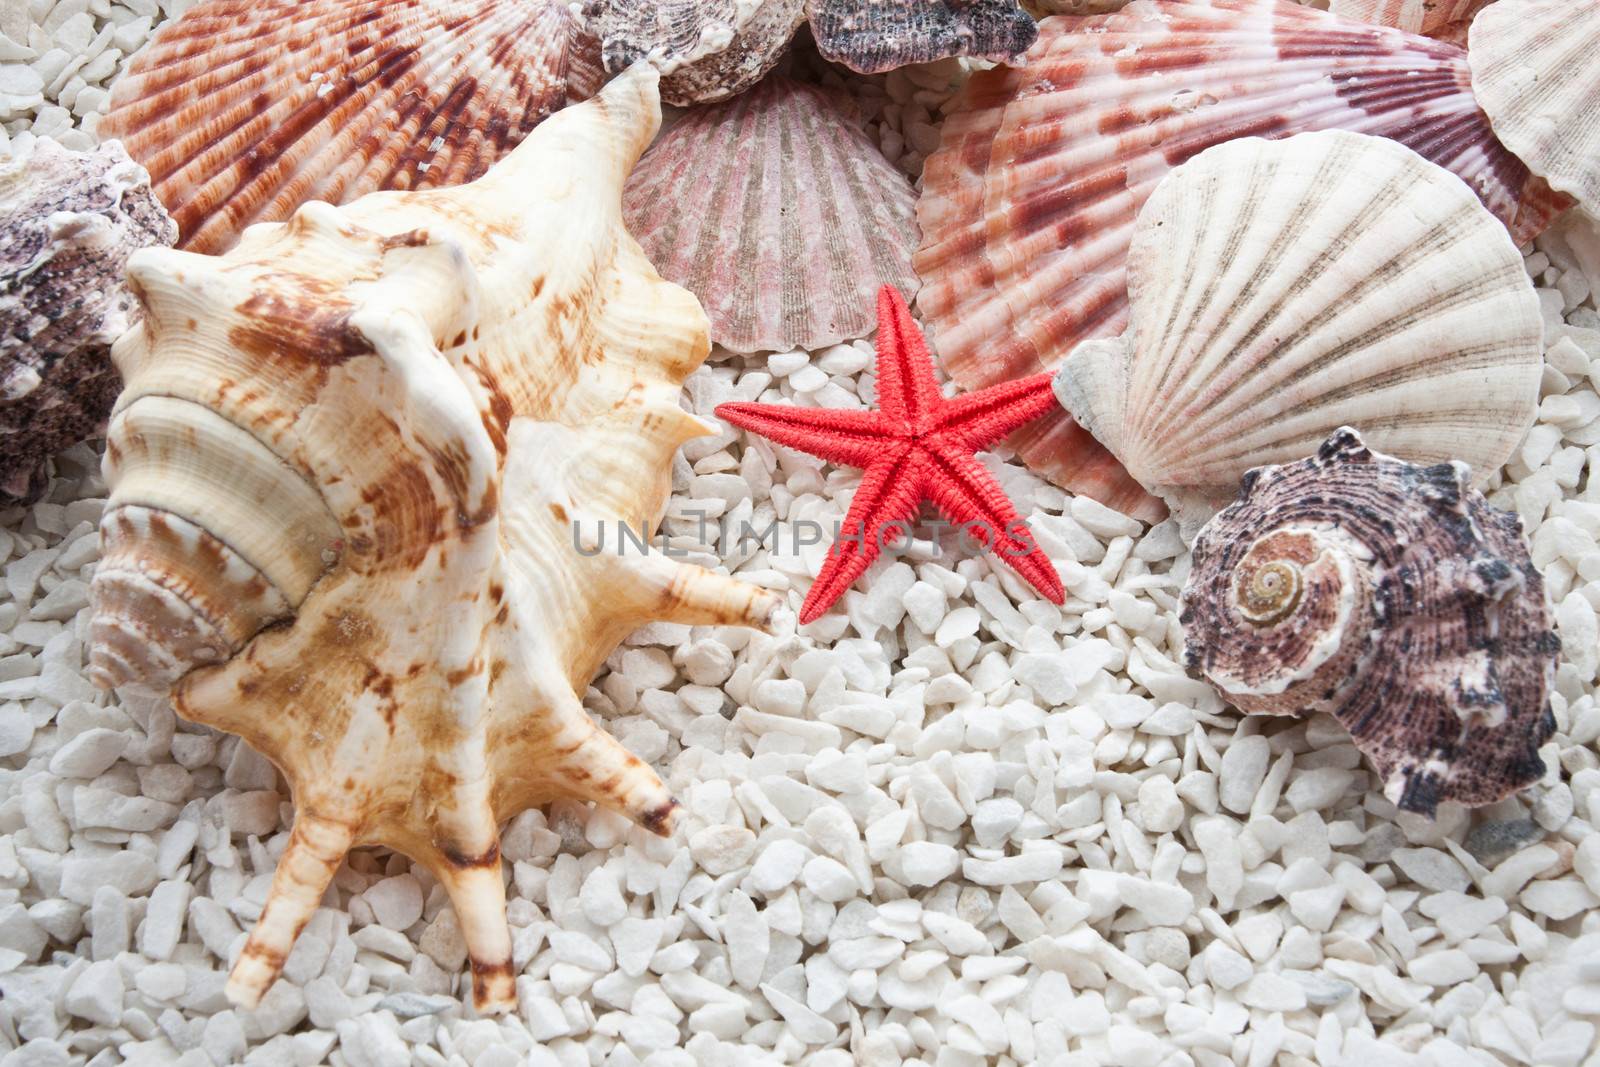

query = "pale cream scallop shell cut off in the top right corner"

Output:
[[1467, 0, 1600, 211]]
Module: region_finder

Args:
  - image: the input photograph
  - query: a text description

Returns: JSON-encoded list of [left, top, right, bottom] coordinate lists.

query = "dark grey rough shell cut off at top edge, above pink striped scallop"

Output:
[[806, 0, 1038, 74]]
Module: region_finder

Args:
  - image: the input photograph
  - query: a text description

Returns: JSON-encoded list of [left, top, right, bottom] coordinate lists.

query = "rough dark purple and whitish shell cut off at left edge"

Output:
[[0, 138, 178, 504]]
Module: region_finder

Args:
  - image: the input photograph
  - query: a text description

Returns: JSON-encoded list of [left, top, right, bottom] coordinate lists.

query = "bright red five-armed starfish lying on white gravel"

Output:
[[717, 285, 1062, 622]]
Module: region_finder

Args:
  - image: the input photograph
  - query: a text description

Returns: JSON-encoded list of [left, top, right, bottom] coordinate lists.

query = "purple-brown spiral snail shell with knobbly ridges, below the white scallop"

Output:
[[1182, 429, 1560, 816]]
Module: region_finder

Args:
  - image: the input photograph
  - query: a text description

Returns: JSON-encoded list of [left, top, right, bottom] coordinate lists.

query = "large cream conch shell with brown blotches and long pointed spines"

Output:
[[91, 67, 778, 1011]]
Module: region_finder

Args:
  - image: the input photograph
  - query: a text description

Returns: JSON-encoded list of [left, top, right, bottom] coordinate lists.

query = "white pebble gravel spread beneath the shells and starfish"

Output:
[[0, 0, 1600, 1067]]
